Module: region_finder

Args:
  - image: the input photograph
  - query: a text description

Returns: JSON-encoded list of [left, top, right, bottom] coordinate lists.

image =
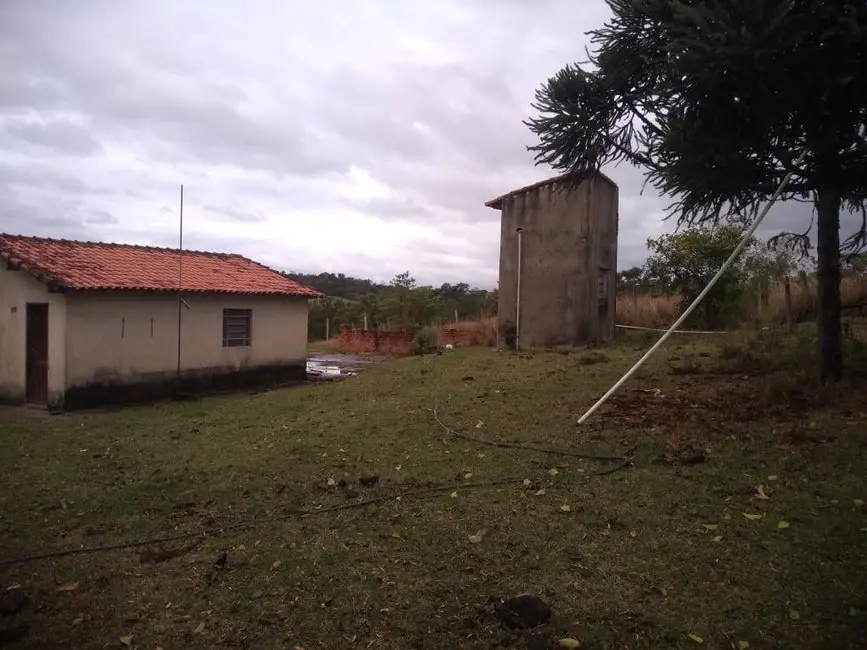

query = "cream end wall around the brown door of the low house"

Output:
[[0, 266, 66, 401]]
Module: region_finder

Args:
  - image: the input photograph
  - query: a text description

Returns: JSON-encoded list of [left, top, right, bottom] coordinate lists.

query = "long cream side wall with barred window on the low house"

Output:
[[66, 292, 308, 387]]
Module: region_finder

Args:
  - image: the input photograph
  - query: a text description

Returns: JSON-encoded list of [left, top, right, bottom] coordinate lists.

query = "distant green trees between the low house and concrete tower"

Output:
[[284, 271, 497, 341]]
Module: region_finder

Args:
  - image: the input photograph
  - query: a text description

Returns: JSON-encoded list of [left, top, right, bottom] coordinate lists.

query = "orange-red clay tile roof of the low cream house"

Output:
[[0, 233, 322, 298]]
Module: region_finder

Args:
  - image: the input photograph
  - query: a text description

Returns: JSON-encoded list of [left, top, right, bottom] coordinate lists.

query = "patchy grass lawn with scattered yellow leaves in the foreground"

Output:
[[0, 333, 867, 650]]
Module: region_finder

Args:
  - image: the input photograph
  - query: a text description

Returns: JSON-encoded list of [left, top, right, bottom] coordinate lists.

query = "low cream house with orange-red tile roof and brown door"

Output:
[[0, 234, 321, 408]]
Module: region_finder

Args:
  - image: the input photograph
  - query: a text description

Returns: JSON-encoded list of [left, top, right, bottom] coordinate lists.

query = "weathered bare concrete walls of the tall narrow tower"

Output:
[[497, 177, 618, 348]]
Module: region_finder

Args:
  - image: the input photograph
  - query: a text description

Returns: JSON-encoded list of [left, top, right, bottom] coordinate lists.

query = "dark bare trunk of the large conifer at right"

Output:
[[816, 187, 843, 381]]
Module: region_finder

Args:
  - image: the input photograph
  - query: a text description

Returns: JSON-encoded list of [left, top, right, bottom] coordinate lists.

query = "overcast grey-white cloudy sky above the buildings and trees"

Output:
[[0, 0, 844, 287]]
